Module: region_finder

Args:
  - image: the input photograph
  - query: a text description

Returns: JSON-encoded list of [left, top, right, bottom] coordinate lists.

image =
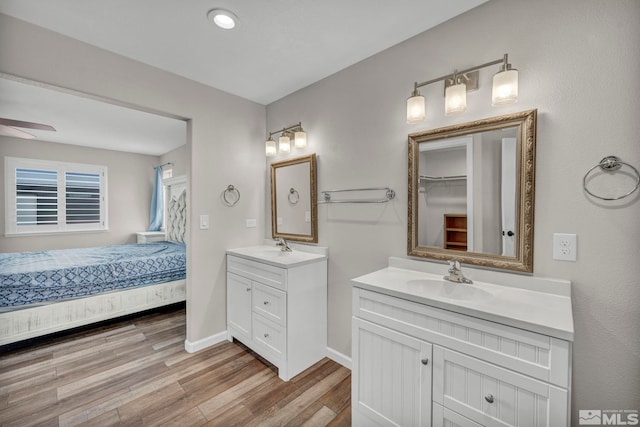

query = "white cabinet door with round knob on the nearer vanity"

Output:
[[351, 317, 432, 426]]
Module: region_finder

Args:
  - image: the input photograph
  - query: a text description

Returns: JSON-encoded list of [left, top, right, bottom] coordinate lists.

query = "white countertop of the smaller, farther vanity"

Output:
[[227, 245, 327, 268]]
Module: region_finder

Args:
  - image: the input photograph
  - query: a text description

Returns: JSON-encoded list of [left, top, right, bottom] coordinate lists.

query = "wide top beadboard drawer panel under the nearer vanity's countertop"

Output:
[[353, 287, 571, 388]]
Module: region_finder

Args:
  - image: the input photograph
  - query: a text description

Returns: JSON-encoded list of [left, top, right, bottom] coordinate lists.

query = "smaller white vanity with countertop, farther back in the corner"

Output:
[[227, 244, 328, 381]]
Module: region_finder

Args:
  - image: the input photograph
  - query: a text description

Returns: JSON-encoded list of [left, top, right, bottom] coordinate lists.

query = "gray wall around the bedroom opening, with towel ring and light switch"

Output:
[[0, 14, 266, 348]]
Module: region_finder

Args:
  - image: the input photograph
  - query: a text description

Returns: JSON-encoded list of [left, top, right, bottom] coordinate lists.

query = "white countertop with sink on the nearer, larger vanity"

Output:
[[353, 265, 573, 341]]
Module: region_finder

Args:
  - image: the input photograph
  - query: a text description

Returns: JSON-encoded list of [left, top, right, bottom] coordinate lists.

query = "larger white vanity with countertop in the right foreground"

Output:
[[351, 258, 573, 427]]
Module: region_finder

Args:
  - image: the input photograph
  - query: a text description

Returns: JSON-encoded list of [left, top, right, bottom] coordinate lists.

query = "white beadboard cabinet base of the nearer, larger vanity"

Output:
[[352, 262, 572, 427]]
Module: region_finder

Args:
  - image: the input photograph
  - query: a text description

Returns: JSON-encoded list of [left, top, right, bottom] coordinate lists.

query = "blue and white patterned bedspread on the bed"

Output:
[[0, 242, 187, 307]]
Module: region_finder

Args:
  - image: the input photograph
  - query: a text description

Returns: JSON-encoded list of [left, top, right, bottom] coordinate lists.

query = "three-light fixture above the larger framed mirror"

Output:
[[407, 53, 518, 124]]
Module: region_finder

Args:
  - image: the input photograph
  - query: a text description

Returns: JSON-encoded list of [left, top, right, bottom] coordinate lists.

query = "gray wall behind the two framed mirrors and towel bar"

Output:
[[267, 0, 640, 416]]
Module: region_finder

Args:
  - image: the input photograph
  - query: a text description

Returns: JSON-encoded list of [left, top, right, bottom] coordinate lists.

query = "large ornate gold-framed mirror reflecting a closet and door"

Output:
[[407, 110, 537, 273]]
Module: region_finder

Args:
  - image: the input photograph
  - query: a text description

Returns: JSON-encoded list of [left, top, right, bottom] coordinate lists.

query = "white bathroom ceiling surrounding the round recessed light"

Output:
[[0, 0, 487, 151]]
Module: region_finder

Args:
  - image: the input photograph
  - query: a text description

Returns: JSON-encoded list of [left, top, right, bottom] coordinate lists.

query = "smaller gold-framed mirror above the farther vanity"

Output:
[[271, 154, 318, 243]]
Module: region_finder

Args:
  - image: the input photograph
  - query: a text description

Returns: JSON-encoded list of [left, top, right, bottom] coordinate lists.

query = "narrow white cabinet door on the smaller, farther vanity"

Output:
[[227, 273, 251, 340]]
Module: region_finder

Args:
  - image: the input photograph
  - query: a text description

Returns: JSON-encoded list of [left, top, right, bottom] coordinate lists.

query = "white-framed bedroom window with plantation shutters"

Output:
[[5, 157, 107, 235]]
